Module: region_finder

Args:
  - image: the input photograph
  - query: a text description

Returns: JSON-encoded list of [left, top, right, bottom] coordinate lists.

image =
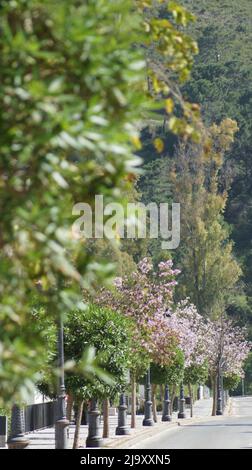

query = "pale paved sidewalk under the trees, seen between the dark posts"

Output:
[[27, 399, 212, 449]]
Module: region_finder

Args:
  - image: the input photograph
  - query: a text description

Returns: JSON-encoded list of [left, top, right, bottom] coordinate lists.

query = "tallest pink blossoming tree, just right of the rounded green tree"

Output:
[[96, 258, 179, 427]]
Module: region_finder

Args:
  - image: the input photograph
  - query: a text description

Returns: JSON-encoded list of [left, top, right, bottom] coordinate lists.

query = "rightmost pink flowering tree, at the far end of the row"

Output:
[[205, 317, 251, 416]]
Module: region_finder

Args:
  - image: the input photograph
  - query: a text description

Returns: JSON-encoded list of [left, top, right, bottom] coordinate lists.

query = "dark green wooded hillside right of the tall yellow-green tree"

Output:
[[183, 0, 252, 312]]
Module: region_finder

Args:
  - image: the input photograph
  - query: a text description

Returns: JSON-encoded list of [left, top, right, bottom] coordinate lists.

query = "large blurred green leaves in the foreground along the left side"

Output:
[[0, 0, 201, 403]]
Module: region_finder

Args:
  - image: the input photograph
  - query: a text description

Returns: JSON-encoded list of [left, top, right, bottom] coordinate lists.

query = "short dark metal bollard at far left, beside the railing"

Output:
[[8, 405, 30, 449]]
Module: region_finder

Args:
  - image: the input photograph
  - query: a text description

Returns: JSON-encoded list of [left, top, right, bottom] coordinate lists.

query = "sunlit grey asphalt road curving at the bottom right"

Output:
[[137, 397, 252, 449]]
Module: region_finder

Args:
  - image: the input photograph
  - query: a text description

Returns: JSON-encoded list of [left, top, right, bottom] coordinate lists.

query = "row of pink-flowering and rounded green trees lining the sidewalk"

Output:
[[33, 258, 250, 448]]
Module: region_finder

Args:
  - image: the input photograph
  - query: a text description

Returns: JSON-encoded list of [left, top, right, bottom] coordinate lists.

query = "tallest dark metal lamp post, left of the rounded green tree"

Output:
[[55, 318, 69, 449]]
